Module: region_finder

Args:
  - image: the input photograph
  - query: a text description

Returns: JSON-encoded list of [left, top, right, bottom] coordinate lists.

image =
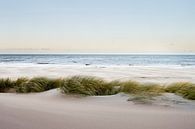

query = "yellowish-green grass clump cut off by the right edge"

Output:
[[165, 82, 195, 100]]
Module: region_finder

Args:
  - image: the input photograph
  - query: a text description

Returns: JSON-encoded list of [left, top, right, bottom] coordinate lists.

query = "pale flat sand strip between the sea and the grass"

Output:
[[0, 64, 195, 83]]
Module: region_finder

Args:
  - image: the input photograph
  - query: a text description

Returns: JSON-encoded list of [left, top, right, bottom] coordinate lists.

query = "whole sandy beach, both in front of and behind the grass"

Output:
[[0, 56, 195, 129]]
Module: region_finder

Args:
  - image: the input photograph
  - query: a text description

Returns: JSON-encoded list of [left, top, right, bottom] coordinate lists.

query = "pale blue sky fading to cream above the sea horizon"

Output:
[[0, 0, 195, 53]]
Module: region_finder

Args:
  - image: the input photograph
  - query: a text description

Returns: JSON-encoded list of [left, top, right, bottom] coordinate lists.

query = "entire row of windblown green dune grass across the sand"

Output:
[[0, 76, 195, 100]]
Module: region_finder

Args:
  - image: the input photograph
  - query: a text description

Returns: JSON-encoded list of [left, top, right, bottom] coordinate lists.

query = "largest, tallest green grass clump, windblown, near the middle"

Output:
[[60, 76, 116, 95]]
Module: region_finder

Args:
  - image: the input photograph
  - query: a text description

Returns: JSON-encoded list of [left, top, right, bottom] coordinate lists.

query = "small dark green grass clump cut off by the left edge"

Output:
[[0, 78, 15, 92]]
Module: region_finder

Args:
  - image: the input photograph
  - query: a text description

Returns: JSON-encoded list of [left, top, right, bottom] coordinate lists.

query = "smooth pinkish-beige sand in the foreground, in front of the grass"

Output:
[[0, 90, 195, 129]]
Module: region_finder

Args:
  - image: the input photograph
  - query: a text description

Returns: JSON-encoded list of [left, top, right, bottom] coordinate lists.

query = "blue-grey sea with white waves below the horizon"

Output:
[[0, 54, 195, 67]]
